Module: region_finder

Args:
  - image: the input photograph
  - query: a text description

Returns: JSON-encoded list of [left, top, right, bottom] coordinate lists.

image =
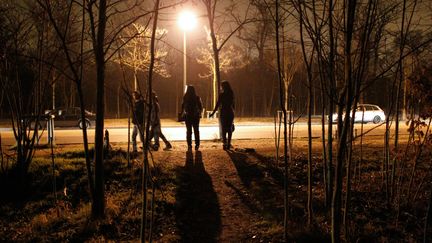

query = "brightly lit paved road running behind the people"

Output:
[[0, 122, 407, 145]]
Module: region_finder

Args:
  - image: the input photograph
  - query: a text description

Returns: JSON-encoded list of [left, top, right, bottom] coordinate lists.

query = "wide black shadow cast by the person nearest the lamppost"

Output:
[[175, 151, 221, 242]]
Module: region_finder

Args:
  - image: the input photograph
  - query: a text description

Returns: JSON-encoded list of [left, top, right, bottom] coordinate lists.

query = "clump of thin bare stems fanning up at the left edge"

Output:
[[0, 1, 58, 186]]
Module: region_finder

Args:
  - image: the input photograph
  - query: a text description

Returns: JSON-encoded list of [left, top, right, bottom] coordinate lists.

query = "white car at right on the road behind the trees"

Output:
[[333, 104, 386, 124]]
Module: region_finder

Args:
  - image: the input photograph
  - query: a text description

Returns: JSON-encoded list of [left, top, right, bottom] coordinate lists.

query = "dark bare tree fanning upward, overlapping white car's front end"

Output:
[[293, 0, 410, 242]]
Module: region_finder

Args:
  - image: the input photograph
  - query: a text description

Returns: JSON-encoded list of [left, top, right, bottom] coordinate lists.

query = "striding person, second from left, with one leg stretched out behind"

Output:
[[150, 91, 172, 151]]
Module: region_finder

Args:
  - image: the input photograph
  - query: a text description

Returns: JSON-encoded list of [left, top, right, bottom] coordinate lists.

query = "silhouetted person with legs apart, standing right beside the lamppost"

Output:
[[182, 85, 203, 150]]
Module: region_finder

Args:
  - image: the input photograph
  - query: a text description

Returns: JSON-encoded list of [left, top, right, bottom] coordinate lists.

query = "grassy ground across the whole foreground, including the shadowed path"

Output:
[[0, 139, 429, 242]]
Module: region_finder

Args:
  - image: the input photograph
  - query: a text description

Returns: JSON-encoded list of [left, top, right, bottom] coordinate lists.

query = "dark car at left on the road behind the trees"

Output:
[[47, 107, 96, 129]]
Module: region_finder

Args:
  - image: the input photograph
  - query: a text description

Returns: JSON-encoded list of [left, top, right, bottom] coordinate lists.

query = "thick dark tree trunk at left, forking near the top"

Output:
[[84, 0, 154, 218]]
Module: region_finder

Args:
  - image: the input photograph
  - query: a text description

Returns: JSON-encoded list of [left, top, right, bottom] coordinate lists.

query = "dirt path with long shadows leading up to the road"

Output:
[[151, 141, 282, 242]]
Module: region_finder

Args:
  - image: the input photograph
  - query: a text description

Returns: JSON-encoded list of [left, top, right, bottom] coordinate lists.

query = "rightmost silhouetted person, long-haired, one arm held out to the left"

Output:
[[210, 80, 235, 149]]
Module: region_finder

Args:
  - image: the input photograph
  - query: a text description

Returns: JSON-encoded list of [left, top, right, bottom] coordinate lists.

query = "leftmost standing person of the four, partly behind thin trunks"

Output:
[[131, 91, 144, 153]]
